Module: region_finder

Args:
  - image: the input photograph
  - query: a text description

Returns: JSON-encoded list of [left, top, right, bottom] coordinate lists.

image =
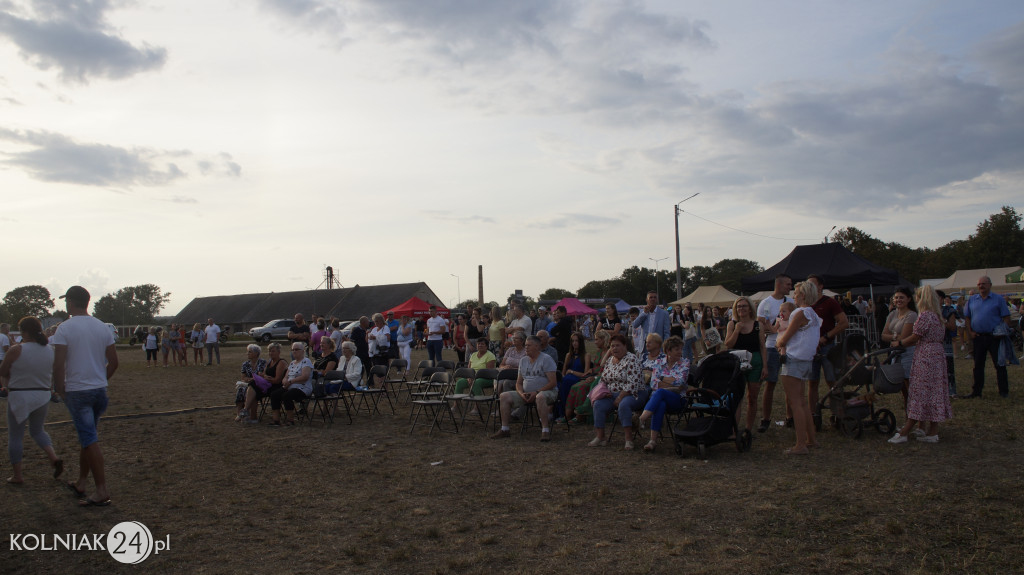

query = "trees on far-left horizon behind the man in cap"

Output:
[[0, 283, 171, 325]]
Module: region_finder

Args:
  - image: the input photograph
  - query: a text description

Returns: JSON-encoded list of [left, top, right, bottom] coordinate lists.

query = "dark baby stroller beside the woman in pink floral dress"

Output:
[[817, 335, 903, 439]]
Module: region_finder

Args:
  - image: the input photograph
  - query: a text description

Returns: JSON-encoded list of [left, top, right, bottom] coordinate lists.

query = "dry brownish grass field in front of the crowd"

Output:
[[0, 339, 1024, 574]]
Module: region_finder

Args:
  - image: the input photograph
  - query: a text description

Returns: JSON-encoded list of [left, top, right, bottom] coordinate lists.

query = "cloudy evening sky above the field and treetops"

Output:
[[0, 0, 1024, 314]]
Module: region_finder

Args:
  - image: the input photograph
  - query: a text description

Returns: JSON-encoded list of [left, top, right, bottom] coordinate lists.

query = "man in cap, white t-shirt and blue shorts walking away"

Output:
[[50, 285, 118, 506]]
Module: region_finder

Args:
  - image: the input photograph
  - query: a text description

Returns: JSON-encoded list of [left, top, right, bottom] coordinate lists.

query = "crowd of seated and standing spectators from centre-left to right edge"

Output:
[[222, 275, 1021, 455]]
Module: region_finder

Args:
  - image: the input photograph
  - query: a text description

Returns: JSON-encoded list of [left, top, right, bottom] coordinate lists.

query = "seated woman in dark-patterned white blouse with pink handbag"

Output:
[[589, 334, 649, 449]]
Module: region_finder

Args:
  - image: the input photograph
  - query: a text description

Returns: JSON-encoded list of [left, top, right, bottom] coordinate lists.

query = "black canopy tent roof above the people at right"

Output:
[[741, 244, 905, 292]]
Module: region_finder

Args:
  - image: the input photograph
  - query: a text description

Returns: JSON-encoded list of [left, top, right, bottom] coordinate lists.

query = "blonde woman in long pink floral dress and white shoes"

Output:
[[889, 285, 953, 443]]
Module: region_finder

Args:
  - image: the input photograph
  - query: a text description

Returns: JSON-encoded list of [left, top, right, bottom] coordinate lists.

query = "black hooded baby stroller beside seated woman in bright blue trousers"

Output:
[[672, 351, 753, 459]]
